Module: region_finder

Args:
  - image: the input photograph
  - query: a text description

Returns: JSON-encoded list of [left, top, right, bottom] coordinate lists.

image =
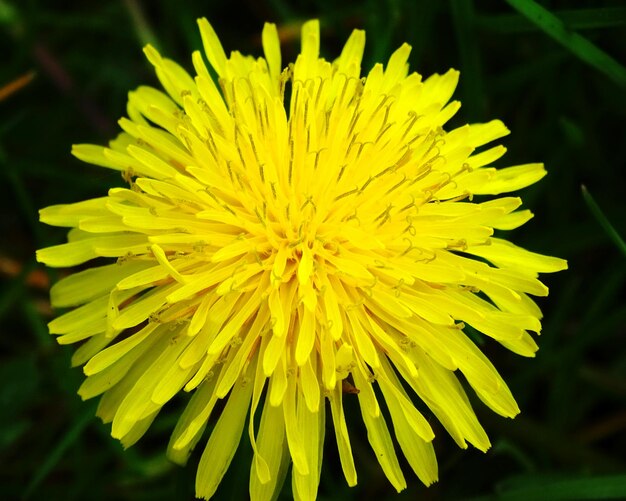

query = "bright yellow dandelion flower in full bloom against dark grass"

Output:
[[37, 19, 566, 499]]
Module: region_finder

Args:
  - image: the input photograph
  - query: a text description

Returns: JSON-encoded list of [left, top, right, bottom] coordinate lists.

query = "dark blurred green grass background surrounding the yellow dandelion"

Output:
[[0, 0, 626, 500]]
